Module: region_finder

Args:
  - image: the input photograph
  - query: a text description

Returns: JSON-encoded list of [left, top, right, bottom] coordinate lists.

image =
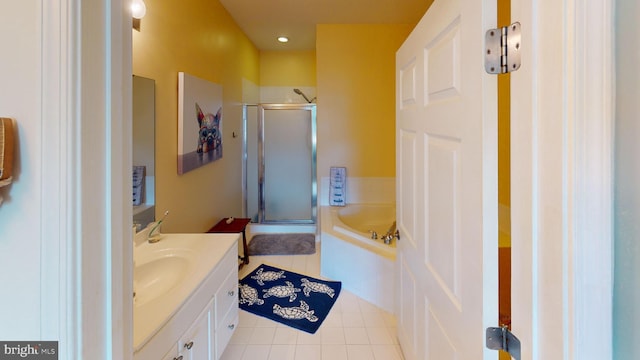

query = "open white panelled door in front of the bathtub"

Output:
[[396, 0, 498, 360]]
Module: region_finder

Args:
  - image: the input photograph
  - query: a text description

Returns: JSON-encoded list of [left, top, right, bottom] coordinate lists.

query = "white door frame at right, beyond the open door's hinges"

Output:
[[511, 0, 614, 359]]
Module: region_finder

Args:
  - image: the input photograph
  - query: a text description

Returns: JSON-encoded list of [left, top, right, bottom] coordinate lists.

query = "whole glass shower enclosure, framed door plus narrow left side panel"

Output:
[[243, 104, 317, 225]]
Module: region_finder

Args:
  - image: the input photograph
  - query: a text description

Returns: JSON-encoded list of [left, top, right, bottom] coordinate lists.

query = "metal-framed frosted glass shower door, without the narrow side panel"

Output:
[[258, 104, 317, 224]]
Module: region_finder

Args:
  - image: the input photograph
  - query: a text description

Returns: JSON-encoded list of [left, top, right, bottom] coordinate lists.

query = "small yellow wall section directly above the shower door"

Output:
[[260, 50, 316, 86]]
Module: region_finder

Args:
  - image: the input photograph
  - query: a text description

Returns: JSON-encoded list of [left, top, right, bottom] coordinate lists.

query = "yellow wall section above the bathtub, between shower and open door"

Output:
[[316, 24, 413, 178]]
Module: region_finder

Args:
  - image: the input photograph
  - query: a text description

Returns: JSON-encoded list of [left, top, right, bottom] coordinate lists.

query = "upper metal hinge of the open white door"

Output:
[[484, 22, 520, 74]]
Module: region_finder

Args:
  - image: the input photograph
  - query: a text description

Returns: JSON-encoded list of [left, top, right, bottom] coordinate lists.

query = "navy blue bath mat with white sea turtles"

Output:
[[238, 264, 342, 334]]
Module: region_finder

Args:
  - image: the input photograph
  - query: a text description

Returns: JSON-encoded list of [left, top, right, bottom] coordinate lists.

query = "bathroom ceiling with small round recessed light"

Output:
[[220, 0, 432, 50]]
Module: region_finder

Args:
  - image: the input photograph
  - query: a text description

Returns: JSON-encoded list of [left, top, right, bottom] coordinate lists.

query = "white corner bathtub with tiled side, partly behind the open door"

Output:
[[320, 204, 396, 312]]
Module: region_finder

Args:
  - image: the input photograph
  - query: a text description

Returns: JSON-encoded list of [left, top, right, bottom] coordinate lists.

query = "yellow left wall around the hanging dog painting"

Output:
[[132, 0, 260, 232]]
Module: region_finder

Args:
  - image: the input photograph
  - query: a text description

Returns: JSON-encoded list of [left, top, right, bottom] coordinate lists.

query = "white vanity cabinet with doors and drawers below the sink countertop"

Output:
[[134, 235, 238, 360]]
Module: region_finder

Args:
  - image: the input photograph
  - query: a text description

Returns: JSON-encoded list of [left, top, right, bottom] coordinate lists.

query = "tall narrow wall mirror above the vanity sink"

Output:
[[132, 75, 156, 231]]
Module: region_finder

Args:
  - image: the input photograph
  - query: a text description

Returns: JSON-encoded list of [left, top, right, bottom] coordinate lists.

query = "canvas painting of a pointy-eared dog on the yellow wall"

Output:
[[178, 72, 222, 174]]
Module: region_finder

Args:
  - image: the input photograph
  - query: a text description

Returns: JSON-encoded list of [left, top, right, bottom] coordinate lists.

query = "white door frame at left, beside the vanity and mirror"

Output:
[[41, 0, 133, 360]]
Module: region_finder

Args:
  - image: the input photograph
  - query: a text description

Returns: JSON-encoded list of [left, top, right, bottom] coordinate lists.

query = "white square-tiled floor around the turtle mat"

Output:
[[222, 245, 403, 360]]
